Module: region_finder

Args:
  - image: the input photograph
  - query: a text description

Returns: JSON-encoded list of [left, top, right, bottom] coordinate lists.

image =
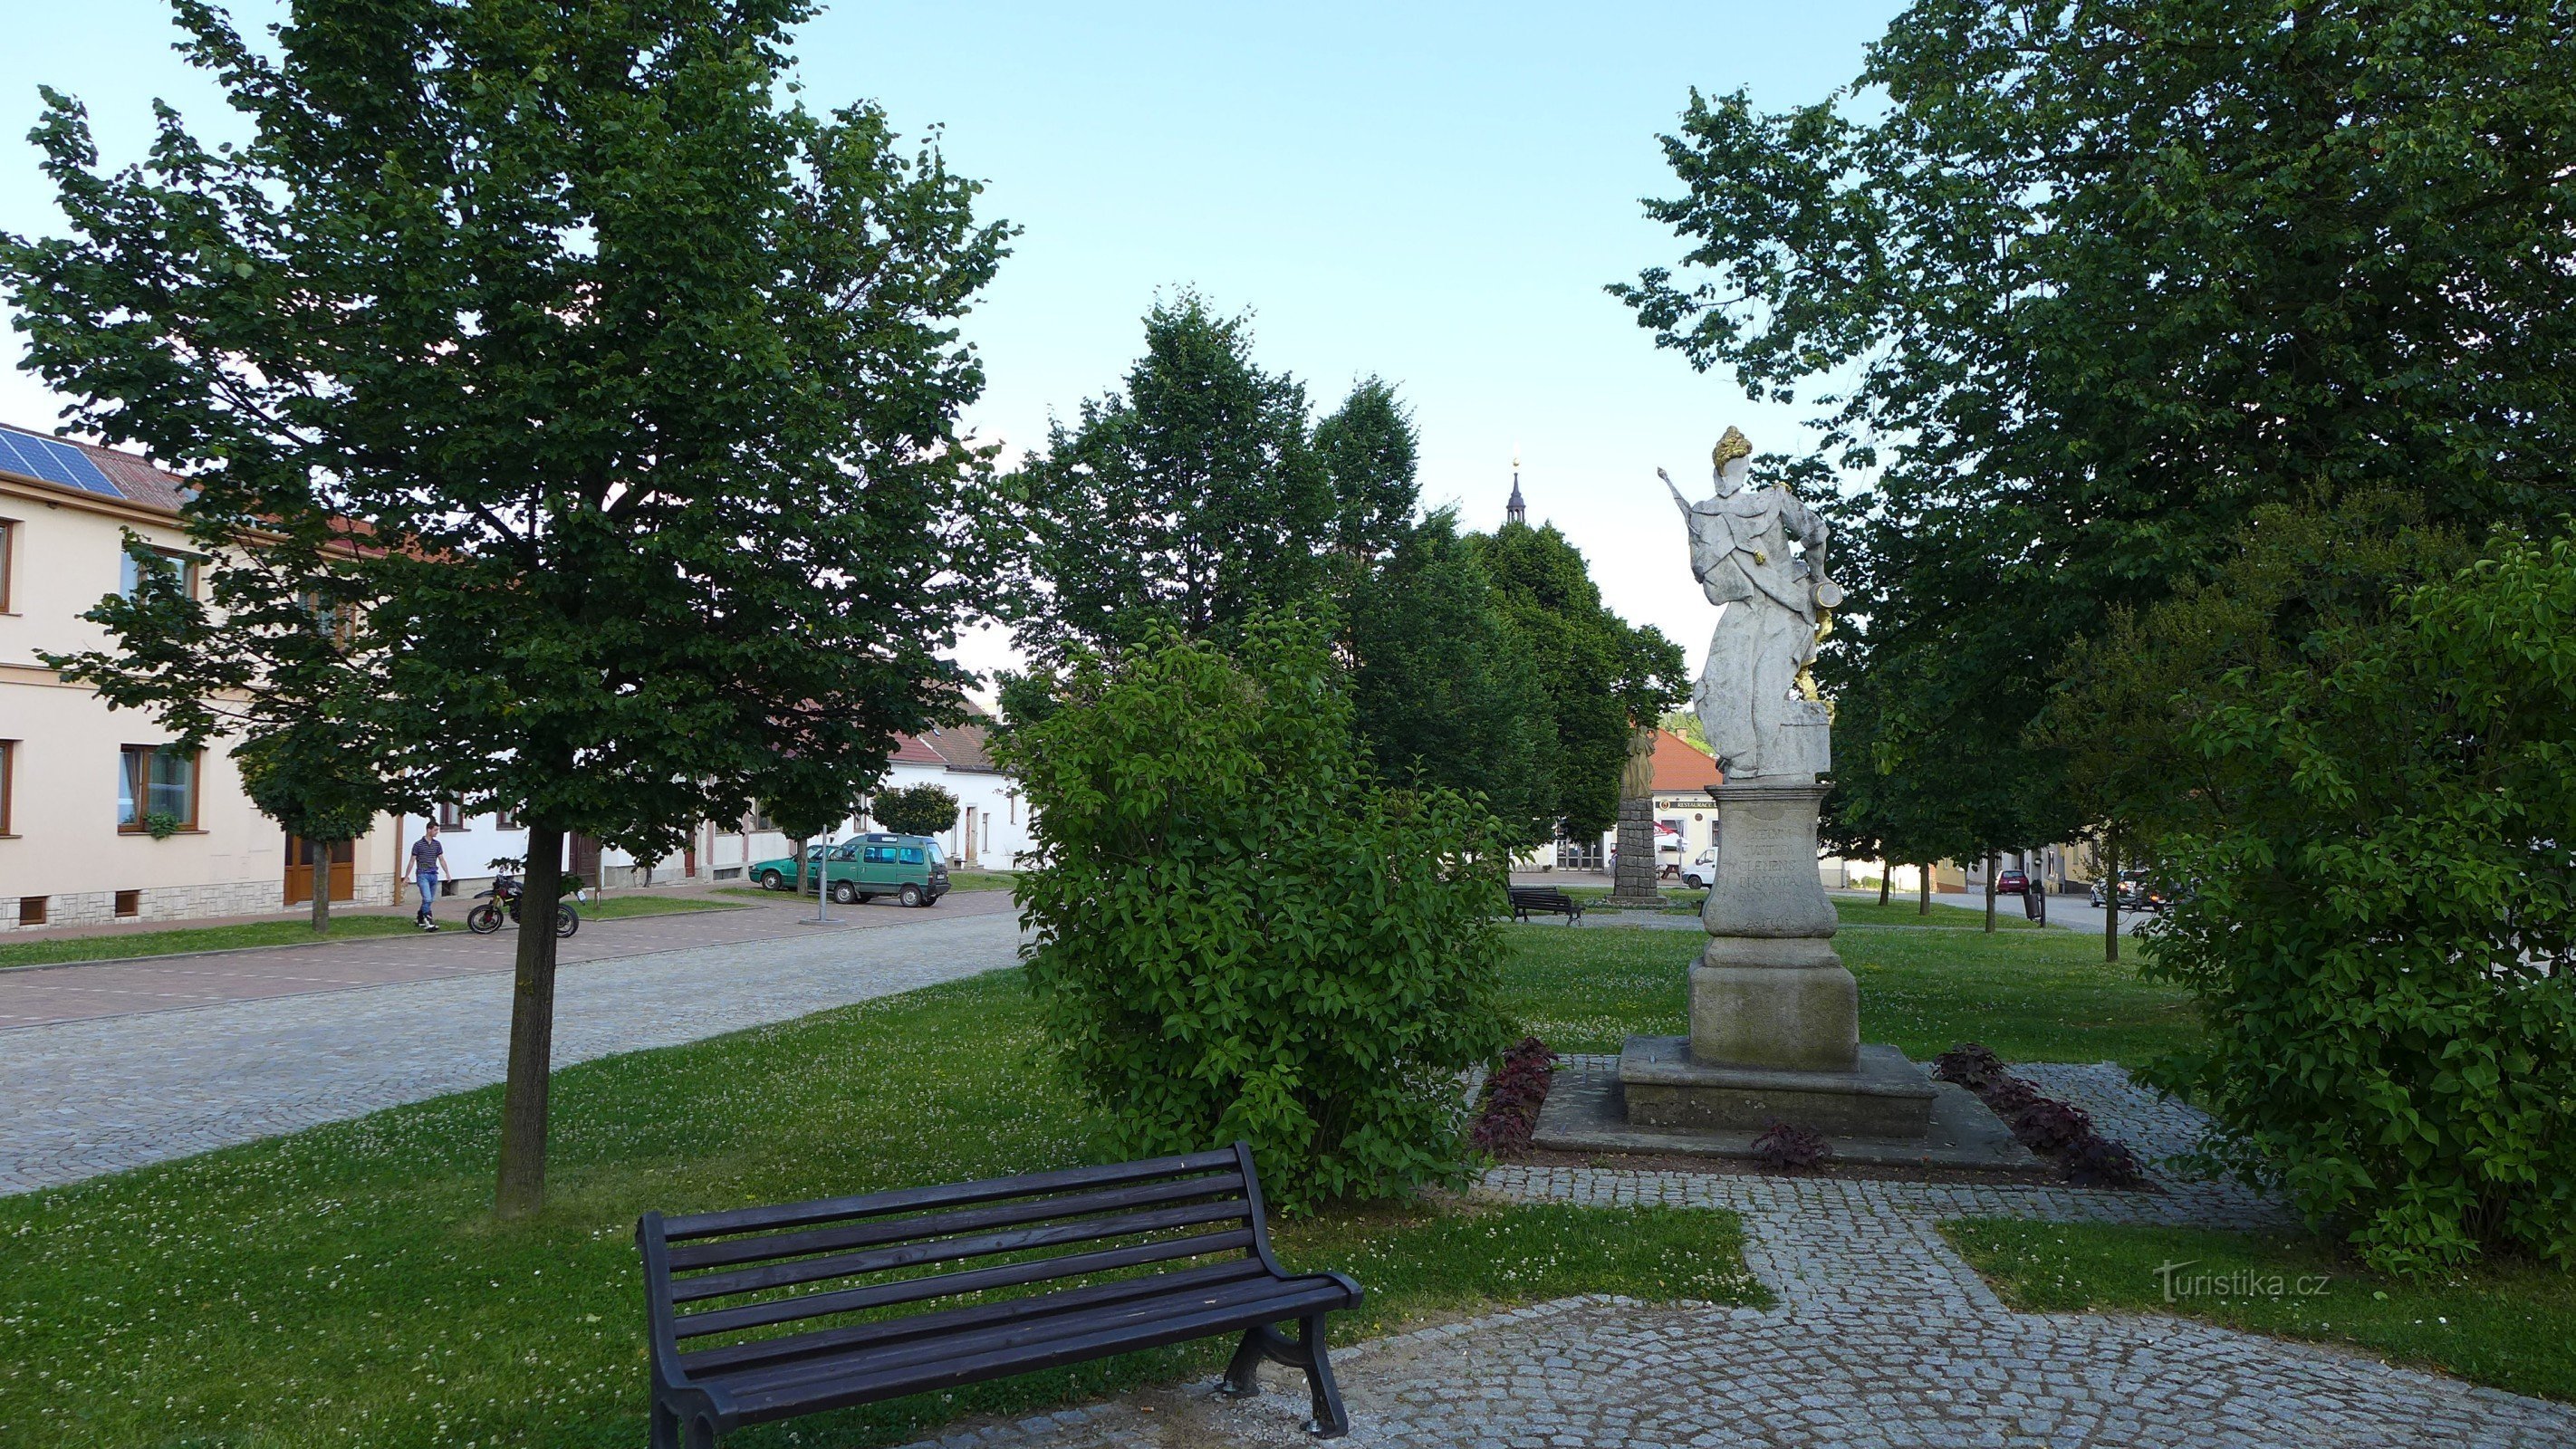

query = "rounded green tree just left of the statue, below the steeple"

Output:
[[1476, 523, 1690, 839]]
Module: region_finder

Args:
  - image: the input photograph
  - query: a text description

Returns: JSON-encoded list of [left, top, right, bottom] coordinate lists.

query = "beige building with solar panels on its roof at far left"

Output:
[[0, 425, 397, 932]]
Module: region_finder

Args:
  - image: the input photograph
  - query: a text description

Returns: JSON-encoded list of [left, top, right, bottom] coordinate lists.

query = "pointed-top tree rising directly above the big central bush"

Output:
[[999, 291, 1329, 661]]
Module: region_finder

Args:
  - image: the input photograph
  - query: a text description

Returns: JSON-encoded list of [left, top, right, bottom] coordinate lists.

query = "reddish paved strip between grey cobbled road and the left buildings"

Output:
[[0, 890, 1010, 1030]]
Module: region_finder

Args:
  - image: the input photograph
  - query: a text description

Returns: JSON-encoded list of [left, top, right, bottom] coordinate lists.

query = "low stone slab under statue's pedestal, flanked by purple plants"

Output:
[[1530, 1037, 2045, 1179]]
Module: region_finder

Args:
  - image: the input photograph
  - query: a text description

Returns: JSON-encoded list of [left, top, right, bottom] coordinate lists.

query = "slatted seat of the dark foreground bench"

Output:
[[735, 1279, 1350, 1421]]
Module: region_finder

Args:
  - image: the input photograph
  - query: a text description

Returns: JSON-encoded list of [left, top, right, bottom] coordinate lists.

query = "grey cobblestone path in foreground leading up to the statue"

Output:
[[891, 1060, 2576, 1449]]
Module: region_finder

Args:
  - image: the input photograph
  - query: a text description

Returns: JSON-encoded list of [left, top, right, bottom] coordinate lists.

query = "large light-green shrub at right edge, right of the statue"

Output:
[[2154, 530, 2576, 1274]]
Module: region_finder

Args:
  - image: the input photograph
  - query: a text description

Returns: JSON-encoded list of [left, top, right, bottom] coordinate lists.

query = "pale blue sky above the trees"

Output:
[[0, 0, 1896, 684]]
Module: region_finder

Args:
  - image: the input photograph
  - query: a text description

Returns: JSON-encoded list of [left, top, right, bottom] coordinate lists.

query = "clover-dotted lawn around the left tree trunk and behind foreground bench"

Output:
[[0, 957, 1764, 1449]]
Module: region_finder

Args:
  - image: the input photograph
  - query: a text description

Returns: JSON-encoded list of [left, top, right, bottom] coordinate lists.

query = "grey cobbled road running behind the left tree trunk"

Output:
[[0, 914, 1020, 1192]]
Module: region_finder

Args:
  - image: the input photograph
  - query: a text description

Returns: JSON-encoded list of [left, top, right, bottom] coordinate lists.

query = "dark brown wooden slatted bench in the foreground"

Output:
[[636, 1143, 1360, 1449]]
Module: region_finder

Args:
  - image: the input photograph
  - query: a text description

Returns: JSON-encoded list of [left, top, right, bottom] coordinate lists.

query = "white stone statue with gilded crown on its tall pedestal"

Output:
[[1618, 427, 1935, 1140]]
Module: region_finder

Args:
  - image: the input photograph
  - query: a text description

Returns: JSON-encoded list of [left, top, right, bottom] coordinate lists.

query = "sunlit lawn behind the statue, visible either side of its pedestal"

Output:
[[1504, 901, 2197, 1066]]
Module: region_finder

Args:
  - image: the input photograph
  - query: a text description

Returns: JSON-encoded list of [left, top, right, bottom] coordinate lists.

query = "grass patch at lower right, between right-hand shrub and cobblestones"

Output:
[[1942, 1220, 2576, 1400]]
